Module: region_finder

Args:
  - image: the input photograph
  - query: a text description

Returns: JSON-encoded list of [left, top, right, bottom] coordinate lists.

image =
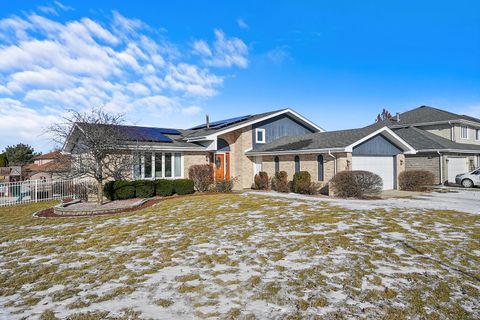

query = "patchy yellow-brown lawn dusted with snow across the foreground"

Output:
[[0, 194, 480, 319]]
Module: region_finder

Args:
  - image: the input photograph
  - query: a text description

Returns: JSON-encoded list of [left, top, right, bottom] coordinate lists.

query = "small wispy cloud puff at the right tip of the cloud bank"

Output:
[[193, 30, 248, 68]]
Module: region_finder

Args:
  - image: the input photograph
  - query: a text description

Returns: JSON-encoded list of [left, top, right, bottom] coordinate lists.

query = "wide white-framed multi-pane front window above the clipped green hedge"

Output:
[[132, 152, 183, 180]]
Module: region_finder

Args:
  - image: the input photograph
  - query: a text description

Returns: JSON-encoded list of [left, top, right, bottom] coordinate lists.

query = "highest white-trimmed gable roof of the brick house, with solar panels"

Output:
[[184, 108, 325, 140]]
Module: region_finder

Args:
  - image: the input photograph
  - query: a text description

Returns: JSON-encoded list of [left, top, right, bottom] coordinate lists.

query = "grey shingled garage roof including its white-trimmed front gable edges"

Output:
[[247, 126, 414, 154]]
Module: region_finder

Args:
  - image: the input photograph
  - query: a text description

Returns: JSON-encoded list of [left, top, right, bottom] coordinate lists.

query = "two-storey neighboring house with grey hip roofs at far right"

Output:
[[377, 106, 480, 183]]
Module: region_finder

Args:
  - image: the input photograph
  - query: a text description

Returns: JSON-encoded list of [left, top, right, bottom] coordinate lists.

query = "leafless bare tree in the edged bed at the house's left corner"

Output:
[[48, 108, 132, 204]]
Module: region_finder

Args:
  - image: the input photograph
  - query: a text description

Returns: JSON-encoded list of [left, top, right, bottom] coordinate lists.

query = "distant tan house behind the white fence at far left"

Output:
[[24, 151, 70, 181]]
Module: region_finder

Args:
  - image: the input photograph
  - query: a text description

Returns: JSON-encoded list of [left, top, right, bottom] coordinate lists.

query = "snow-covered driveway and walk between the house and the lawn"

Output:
[[248, 190, 480, 214]]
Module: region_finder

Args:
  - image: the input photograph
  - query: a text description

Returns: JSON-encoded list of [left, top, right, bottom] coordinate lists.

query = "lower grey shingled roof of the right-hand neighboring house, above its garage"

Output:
[[393, 127, 480, 152]]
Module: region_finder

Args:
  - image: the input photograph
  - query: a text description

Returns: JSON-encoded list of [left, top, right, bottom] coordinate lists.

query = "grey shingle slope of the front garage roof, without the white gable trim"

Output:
[[254, 126, 379, 152]]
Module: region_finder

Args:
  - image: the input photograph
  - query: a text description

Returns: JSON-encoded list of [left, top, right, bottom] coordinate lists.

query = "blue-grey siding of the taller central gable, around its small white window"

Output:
[[252, 115, 313, 150]]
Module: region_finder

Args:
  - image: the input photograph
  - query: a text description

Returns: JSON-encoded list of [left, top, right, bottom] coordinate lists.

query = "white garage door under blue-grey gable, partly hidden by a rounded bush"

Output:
[[352, 156, 395, 190]]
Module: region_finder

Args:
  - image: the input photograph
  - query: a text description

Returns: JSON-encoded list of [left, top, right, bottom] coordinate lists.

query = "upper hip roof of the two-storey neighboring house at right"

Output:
[[380, 106, 480, 126]]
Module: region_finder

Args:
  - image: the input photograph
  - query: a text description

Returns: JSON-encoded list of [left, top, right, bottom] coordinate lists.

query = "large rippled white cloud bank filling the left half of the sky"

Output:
[[0, 8, 248, 150]]
